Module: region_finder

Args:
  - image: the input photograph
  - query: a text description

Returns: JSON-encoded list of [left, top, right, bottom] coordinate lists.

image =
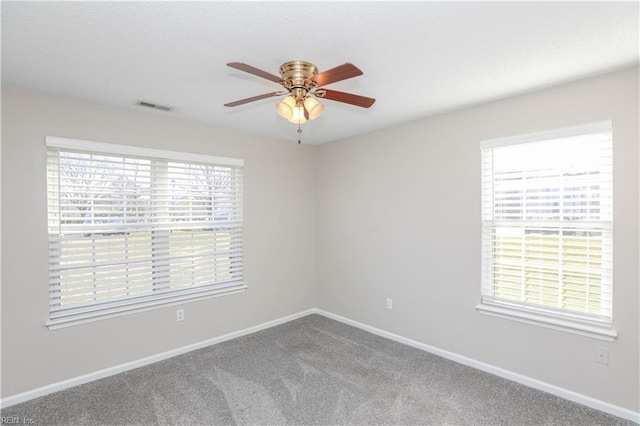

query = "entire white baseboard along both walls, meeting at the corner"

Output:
[[0, 308, 640, 423]]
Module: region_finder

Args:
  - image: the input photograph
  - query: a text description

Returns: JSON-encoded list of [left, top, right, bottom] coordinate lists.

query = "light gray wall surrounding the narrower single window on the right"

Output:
[[316, 68, 640, 412]]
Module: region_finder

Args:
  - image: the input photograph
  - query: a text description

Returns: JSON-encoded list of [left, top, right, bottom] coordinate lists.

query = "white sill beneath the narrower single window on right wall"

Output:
[[476, 302, 618, 342]]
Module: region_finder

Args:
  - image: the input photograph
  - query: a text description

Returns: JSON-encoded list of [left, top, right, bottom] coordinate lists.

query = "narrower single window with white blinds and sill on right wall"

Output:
[[477, 122, 616, 340]]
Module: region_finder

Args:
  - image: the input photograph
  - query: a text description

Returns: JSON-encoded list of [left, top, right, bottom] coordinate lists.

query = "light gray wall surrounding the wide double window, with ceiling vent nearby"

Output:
[[2, 87, 315, 397]]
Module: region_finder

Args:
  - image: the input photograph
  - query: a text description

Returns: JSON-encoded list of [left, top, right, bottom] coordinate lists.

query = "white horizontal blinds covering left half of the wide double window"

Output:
[[48, 149, 152, 312]]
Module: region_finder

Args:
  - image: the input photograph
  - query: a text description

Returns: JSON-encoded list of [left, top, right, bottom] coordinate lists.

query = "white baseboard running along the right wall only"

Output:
[[312, 309, 640, 423]]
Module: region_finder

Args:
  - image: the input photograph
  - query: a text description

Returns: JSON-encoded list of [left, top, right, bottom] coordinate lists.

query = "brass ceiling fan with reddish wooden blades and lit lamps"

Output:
[[224, 61, 376, 124]]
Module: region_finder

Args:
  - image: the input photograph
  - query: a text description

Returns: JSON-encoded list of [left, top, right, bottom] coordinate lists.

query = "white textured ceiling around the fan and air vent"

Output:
[[2, 1, 639, 144]]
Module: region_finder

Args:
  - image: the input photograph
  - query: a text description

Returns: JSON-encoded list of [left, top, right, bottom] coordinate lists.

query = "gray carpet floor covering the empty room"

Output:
[[2, 315, 633, 425]]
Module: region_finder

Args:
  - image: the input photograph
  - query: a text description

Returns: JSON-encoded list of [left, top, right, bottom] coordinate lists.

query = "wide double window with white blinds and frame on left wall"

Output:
[[46, 137, 246, 329]]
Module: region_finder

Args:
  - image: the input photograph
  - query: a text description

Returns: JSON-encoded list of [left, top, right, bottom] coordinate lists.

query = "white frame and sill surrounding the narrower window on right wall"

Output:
[[476, 121, 617, 341]]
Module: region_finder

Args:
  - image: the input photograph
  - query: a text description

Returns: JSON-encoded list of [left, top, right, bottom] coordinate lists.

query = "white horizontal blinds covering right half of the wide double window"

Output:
[[154, 162, 243, 296]]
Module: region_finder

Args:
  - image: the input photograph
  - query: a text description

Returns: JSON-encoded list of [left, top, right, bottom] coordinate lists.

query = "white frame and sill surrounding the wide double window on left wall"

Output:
[[45, 136, 248, 330]]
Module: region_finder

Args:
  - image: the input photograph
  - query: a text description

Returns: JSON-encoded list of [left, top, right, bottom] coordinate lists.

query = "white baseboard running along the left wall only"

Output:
[[0, 309, 316, 408]]
